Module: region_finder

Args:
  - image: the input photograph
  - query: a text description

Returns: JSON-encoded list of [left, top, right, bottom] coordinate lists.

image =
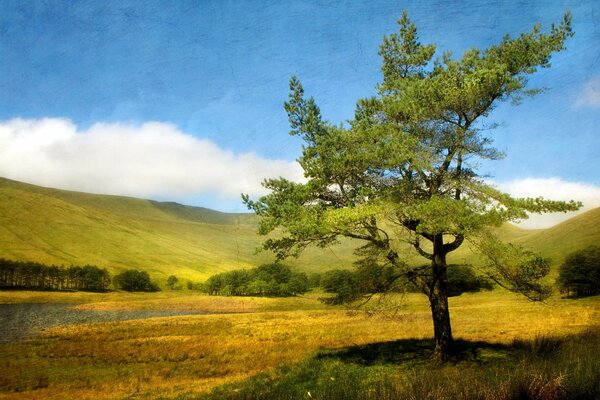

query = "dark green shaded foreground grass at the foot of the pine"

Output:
[[201, 329, 600, 400]]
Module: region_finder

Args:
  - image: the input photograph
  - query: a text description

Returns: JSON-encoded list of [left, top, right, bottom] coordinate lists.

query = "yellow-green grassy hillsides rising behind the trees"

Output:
[[0, 178, 600, 280]]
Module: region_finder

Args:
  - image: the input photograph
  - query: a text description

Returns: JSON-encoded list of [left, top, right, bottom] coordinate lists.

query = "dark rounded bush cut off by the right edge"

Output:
[[557, 246, 600, 297]]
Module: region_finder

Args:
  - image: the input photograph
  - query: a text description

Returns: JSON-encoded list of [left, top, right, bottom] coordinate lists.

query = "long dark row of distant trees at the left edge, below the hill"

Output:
[[0, 258, 110, 291]]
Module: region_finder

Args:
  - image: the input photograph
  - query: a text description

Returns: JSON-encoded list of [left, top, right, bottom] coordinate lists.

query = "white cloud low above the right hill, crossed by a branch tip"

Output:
[[497, 178, 600, 229]]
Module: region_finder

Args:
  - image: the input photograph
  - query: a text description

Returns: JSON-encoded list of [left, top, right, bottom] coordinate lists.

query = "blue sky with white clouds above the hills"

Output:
[[0, 0, 600, 225]]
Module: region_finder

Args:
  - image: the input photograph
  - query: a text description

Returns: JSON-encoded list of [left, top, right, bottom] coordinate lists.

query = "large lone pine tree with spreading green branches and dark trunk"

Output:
[[242, 12, 580, 360]]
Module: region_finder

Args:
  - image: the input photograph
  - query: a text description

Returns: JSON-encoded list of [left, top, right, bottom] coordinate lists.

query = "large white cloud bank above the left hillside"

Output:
[[0, 118, 302, 199]]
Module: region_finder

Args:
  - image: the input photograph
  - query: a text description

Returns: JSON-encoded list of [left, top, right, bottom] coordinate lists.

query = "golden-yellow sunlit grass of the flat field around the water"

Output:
[[0, 291, 600, 399]]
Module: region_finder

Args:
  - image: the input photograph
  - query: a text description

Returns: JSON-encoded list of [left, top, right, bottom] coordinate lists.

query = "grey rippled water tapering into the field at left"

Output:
[[0, 304, 211, 343]]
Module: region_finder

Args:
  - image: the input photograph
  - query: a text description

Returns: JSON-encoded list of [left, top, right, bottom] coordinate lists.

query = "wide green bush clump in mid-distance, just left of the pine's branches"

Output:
[[205, 263, 308, 296]]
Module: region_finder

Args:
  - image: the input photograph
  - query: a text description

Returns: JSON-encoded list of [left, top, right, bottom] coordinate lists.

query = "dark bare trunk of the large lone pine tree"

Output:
[[429, 235, 453, 362]]
